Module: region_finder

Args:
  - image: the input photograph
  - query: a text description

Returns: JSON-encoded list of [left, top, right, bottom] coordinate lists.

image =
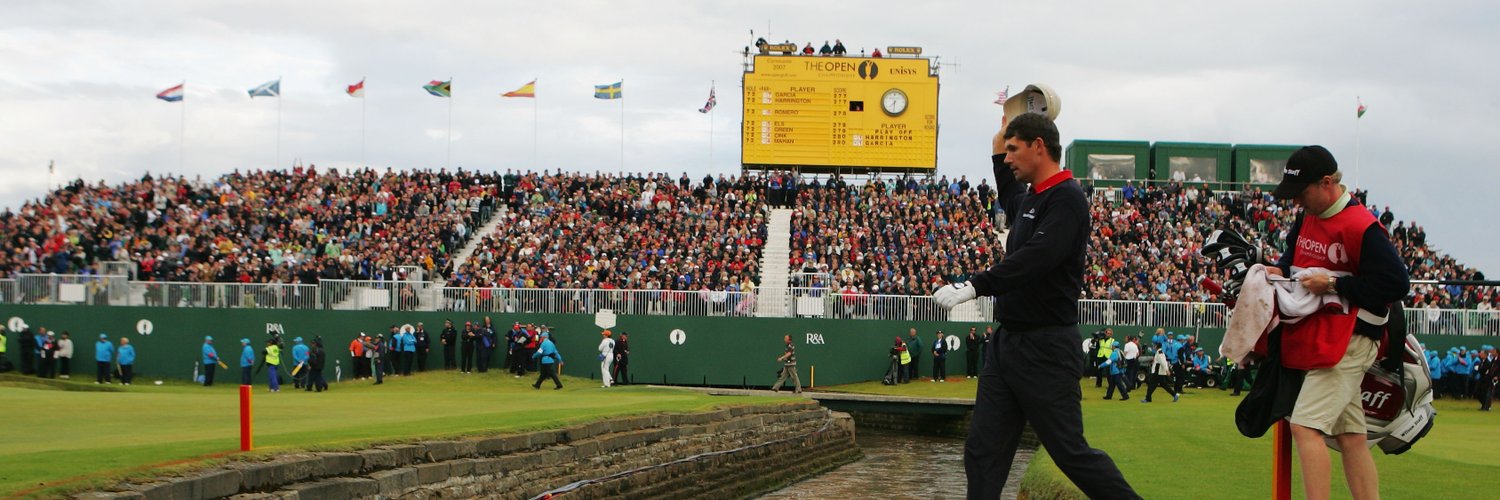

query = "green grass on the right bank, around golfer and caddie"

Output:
[[818, 378, 1500, 498]]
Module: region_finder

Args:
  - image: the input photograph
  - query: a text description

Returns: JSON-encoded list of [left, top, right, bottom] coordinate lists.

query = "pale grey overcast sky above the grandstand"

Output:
[[0, 0, 1500, 273]]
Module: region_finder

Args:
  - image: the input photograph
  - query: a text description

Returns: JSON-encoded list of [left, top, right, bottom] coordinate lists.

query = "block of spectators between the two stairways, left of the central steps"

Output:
[[449, 173, 767, 303]]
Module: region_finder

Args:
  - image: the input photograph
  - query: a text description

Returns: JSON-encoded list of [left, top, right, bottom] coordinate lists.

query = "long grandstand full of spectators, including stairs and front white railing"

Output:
[[0, 154, 1500, 333]]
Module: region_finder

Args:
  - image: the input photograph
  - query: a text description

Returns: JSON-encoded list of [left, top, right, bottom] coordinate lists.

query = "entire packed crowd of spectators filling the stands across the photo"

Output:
[[0, 167, 1500, 309]]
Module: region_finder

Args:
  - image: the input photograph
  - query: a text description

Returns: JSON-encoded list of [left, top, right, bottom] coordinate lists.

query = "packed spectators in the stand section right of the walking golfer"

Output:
[[1085, 182, 1500, 309]]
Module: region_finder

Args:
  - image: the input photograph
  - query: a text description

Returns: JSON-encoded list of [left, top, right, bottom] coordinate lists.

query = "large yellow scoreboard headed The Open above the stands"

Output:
[[740, 56, 938, 170]]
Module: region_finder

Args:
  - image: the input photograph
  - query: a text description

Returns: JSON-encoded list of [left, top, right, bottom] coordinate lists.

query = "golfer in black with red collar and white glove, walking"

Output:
[[933, 113, 1140, 498]]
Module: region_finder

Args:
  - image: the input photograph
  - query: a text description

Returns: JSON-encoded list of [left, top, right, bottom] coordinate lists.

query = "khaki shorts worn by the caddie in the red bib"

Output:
[[1292, 333, 1380, 435]]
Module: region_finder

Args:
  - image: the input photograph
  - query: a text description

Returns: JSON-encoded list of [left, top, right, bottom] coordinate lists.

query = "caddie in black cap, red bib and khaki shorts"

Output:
[[1266, 146, 1412, 498]]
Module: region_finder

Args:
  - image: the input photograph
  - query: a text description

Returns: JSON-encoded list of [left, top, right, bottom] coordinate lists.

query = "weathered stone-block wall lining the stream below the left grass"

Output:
[[78, 401, 861, 498]]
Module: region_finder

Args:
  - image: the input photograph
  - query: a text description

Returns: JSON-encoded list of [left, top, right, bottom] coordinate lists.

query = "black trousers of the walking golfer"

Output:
[[963, 326, 1140, 500]]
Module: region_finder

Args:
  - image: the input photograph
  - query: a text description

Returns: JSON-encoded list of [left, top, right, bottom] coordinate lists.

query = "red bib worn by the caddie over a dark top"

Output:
[[1281, 203, 1379, 369]]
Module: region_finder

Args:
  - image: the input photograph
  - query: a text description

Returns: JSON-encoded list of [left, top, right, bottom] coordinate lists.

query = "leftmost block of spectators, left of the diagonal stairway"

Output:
[[0, 167, 500, 297]]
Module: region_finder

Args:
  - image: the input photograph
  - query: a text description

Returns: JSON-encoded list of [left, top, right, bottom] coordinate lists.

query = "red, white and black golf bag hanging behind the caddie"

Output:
[[1325, 303, 1437, 455]]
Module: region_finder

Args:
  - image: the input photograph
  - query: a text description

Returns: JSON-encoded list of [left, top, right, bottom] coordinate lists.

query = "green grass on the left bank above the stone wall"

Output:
[[0, 372, 780, 497]]
